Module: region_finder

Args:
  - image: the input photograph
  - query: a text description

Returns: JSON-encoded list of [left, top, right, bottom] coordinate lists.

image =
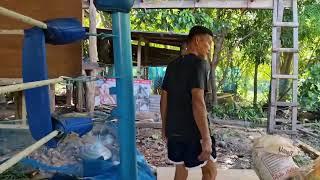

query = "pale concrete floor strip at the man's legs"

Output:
[[157, 167, 259, 180]]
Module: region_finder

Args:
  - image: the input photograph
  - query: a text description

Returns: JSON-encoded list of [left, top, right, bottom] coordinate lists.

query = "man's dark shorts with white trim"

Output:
[[167, 137, 217, 168]]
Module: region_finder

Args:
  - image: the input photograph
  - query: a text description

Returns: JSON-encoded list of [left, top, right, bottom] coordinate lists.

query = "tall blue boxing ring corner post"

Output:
[[112, 12, 137, 180]]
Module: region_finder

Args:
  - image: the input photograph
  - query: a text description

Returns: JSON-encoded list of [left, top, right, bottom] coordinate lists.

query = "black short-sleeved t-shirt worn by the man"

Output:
[[162, 54, 209, 140]]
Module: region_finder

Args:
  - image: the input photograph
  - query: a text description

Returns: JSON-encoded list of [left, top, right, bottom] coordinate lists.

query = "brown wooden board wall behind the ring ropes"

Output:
[[0, 0, 82, 78]]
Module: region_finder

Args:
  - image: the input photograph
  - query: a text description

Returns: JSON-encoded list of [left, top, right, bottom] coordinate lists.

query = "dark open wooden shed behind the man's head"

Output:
[[97, 29, 187, 66]]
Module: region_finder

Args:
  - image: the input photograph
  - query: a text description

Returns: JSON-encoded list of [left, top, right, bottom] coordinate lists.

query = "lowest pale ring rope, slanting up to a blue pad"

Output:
[[0, 130, 59, 174]]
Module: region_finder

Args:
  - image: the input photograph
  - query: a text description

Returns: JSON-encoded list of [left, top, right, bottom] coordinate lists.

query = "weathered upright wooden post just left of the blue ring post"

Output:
[[86, 1, 98, 112]]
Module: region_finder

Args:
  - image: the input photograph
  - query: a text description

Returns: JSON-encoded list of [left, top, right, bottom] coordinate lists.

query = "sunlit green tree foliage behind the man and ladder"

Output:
[[92, 0, 320, 114]]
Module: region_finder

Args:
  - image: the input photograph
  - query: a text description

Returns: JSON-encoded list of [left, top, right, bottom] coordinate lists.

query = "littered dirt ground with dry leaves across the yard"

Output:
[[0, 104, 320, 179]]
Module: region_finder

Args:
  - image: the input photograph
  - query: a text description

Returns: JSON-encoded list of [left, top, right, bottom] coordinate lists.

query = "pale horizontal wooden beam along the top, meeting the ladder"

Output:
[[133, 0, 292, 9]]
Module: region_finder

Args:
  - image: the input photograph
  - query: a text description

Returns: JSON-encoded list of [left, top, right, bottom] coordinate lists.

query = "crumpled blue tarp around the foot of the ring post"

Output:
[[21, 123, 156, 180]]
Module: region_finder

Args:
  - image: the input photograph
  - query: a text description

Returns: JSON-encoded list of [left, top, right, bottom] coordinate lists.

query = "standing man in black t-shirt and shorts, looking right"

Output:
[[160, 26, 217, 180]]
